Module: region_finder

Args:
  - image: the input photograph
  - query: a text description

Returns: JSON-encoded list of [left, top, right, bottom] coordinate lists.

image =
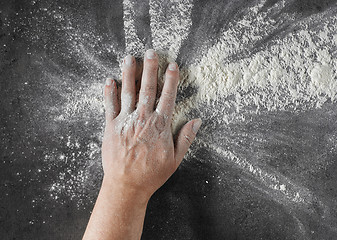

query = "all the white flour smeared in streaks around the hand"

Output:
[[24, 0, 337, 231]]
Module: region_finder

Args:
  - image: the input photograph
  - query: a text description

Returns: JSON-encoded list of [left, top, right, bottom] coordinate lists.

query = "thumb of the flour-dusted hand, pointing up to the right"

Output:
[[175, 118, 202, 167]]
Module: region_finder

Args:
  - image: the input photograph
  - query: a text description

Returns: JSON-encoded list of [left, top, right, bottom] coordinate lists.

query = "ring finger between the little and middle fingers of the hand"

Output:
[[121, 55, 136, 113]]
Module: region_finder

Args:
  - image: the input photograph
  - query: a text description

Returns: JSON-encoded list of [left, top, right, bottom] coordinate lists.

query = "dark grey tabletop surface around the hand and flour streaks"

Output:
[[0, 0, 337, 240]]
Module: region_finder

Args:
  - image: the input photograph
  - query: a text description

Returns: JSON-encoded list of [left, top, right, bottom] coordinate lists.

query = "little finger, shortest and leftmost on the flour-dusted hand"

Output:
[[104, 78, 120, 122]]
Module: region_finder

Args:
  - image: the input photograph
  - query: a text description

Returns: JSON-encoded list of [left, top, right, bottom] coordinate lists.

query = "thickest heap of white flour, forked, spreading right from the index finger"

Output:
[[174, 6, 337, 129]]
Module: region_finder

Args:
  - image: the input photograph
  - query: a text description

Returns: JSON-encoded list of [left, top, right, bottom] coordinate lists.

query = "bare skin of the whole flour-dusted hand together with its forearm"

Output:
[[83, 50, 201, 240]]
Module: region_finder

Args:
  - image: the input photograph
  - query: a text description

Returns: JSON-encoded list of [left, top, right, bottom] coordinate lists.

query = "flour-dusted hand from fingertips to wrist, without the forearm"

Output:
[[102, 50, 201, 198]]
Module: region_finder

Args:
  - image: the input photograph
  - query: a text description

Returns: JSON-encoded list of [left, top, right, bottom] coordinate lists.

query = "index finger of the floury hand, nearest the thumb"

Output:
[[157, 63, 179, 119]]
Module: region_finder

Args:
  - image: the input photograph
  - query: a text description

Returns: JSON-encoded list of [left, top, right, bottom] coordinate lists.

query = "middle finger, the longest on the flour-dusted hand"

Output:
[[138, 49, 158, 113]]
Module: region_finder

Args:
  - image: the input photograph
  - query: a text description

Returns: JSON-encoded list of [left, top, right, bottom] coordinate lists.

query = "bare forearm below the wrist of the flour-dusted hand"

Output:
[[83, 179, 149, 240]]
